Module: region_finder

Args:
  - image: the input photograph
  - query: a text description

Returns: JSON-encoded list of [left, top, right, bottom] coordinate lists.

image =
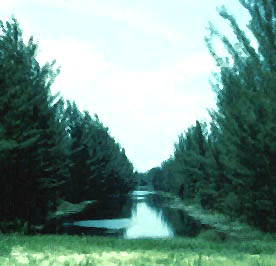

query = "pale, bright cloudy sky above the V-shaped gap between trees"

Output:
[[0, 0, 249, 171]]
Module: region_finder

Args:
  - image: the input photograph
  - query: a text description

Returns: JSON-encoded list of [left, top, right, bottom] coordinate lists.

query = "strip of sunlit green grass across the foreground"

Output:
[[0, 231, 276, 266]]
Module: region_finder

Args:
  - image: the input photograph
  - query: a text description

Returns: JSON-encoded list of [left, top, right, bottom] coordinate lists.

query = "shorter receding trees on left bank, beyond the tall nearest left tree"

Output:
[[65, 102, 134, 203]]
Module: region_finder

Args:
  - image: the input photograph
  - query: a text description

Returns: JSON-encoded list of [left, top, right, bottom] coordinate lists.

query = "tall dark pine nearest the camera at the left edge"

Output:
[[0, 19, 64, 230]]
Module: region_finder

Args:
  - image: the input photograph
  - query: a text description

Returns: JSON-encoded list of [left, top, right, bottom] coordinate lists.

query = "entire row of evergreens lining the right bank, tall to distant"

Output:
[[147, 0, 276, 232]]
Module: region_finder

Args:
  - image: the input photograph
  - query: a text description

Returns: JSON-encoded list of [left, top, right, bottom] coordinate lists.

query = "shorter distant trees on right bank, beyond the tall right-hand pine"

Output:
[[153, 121, 209, 199]]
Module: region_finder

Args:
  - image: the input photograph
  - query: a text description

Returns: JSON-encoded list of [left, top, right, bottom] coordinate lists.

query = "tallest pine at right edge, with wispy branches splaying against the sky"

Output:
[[207, 0, 276, 231]]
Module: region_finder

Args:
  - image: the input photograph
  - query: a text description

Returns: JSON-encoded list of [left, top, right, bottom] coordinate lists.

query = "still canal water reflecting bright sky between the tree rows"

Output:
[[64, 190, 209, 239]]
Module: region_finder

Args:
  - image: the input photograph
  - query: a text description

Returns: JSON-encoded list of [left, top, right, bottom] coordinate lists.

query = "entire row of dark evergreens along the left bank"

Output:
[[0, 19, 135, 233]]
